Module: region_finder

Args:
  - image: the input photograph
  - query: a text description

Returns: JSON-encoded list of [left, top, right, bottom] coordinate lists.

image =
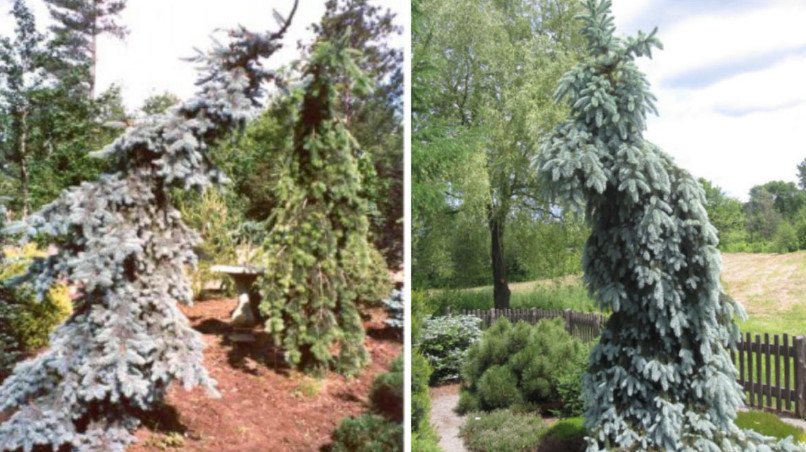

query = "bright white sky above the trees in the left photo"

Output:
[[0, 0, 410, 115]]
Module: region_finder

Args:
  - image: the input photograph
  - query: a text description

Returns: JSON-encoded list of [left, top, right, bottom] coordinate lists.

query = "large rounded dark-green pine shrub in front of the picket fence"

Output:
[[460, 318, 589, 413]]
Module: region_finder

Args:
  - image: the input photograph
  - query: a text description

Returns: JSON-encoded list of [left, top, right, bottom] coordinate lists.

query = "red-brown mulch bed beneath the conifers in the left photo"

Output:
[[129, 299, 403, 451]]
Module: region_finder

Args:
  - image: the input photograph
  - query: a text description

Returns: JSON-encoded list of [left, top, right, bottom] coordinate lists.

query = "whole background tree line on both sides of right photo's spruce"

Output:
[[412, 0, 806, 307]]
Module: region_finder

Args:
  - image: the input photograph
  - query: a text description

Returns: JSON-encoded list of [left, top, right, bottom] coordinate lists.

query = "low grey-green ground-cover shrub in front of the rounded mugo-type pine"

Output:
[[460, 409, 545, 452]]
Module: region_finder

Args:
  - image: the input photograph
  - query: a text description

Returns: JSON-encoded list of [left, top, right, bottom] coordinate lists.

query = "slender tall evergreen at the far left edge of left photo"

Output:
[[0, 0, 46, 216]]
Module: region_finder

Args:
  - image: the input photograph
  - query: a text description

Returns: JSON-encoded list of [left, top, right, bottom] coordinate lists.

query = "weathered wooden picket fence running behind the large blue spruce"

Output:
[[454, 308, 806, 418]]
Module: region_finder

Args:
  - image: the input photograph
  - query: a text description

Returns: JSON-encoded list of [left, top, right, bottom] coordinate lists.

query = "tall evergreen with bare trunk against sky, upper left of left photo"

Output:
[[45, 0, 128, 97]]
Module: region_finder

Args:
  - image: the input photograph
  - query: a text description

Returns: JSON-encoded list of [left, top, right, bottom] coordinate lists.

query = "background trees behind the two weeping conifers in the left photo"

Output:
[[0, 0, 403, 265]]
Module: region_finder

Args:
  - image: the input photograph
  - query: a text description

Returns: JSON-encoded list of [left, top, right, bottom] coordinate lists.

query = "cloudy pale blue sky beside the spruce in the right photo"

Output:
[[613, 0, 806, 200]]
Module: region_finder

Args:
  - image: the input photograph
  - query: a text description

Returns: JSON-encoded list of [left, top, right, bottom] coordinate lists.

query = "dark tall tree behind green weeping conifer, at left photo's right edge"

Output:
[[313, 0, 403, 263]]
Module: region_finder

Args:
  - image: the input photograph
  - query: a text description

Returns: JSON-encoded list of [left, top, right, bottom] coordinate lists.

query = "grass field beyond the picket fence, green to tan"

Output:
[[428, 251, 806, 336]]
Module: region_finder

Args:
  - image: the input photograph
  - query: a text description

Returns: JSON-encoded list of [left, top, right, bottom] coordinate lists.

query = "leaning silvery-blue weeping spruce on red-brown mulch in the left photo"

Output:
[[0, 7, 296, 451]]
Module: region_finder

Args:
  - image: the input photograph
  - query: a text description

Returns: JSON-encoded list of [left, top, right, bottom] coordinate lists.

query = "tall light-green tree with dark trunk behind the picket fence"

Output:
[[412, 1, 580, 308]]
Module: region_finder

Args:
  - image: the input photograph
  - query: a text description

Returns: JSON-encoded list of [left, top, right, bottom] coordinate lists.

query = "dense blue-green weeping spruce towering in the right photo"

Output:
[[537, 0, 798, 452]]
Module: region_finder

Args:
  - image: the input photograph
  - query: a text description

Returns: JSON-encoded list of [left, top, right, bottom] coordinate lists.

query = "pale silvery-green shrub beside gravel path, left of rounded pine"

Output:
[[417, 315, 481, 384]]
